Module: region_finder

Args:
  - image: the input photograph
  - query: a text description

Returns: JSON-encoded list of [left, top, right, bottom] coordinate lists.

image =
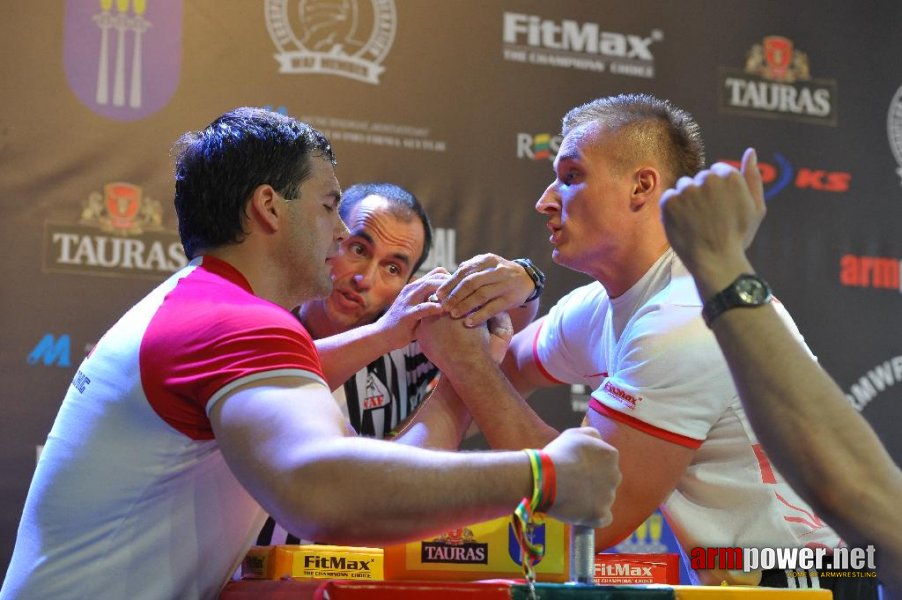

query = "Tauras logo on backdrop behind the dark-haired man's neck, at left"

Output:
[[43, 182, 188, 278]]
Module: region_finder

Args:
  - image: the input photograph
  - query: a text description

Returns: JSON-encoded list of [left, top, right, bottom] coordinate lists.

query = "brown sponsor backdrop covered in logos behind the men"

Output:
[[0, 0, 902, 571]]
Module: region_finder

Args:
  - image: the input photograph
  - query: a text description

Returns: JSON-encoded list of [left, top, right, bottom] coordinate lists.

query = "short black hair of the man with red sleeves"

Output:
[[175, 107, 335, 259]]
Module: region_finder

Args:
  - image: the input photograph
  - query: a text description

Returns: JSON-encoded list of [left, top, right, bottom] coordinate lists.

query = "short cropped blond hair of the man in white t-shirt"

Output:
[[561, 94, 705, 185]]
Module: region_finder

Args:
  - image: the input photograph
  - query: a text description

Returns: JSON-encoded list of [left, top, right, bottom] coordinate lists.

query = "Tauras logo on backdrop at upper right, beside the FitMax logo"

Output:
[[720, 35, 837, 126]]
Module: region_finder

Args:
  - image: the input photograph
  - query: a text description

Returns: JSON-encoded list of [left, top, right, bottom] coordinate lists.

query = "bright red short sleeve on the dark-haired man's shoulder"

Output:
[[140, 274, 325, 440]]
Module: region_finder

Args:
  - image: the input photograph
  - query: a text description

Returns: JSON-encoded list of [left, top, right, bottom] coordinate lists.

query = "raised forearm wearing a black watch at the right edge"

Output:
[[697, 255, 902, 542]]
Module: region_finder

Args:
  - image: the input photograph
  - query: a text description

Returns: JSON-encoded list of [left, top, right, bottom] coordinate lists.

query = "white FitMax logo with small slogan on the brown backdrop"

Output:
[[503, 12, 664, 78]]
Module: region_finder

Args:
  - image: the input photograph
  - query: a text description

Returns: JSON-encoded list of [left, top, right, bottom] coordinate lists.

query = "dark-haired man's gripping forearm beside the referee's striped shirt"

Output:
[[395, 377, 472, 450]]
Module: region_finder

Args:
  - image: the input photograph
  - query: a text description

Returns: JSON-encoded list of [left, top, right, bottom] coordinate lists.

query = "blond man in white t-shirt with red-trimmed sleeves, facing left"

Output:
[[430, 95, 876, 587]]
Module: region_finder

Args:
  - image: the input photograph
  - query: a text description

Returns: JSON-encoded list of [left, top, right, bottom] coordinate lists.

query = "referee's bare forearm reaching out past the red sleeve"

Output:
[[314, 323, 395, 390]]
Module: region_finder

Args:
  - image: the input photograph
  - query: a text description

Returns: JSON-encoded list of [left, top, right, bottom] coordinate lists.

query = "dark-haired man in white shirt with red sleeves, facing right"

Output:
[[0, 109, 619, 600]]
